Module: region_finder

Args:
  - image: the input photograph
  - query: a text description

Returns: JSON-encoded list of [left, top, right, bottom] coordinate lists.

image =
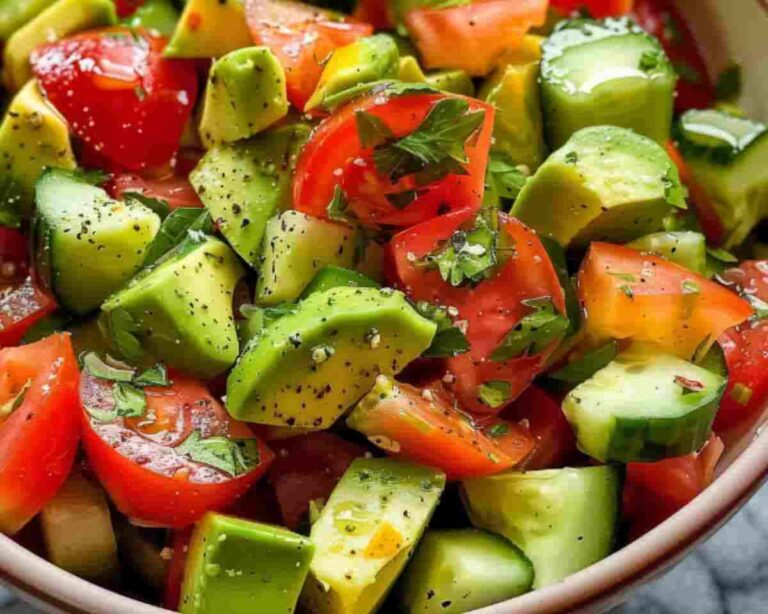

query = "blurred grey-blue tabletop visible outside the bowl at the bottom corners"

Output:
[[0, 486, 768, 614]]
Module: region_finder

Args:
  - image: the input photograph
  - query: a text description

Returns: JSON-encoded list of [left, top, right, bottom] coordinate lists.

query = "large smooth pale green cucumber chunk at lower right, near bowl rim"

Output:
[[462, 466, 622, 589]]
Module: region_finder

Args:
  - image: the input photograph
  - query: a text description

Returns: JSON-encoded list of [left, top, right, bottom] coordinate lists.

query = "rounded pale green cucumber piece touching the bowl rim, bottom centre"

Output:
[[396, 529, 533, 614]]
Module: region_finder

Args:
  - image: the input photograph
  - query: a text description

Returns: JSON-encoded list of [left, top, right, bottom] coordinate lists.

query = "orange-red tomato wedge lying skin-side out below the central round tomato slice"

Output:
[[348, 382, 534, 480]]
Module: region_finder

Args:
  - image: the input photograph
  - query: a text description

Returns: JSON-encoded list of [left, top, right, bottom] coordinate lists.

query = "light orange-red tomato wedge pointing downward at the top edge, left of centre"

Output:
[[245, 0, 373, 111]]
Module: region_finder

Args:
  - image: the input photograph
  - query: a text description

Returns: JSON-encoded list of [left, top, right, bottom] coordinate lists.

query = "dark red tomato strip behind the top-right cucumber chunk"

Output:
[[634, 0, 715, 112]]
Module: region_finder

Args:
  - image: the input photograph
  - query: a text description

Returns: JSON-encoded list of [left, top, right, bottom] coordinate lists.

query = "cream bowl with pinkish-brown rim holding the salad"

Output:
[[0, 0, 768, 614]]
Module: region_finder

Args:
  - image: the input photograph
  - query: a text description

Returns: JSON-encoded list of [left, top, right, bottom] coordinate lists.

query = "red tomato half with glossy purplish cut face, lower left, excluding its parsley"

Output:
[[80, 373, 274, 528]]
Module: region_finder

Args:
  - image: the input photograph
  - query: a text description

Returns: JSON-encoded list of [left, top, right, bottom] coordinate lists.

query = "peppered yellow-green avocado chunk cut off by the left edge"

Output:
[[0, 81, 77, 226]]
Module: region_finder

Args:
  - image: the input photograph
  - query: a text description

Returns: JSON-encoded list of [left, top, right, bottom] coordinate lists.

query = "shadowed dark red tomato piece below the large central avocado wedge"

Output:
[[269, 432, 366, 529]]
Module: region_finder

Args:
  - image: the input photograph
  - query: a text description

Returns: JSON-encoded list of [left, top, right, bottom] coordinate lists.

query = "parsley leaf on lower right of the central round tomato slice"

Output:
[[491, 298, 569, 362]]
